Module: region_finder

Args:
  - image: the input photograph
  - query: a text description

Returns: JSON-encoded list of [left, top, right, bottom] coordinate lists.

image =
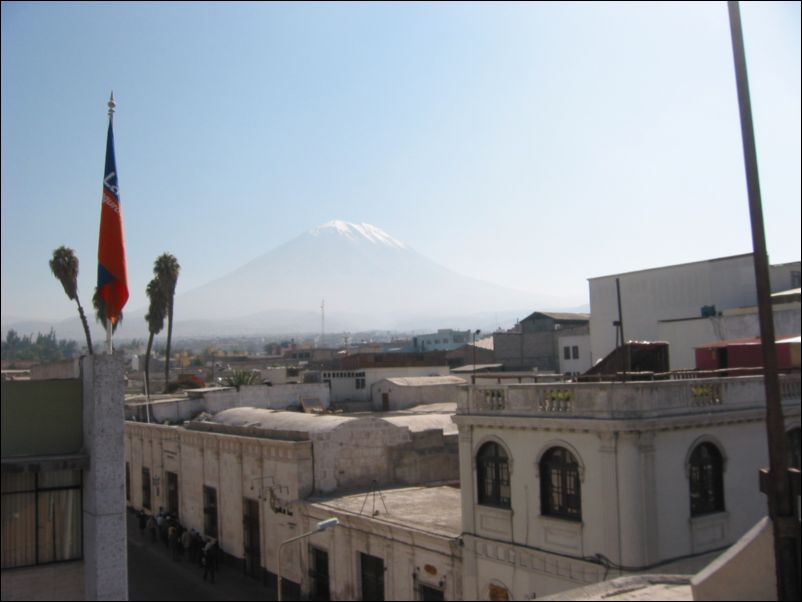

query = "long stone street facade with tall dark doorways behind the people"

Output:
[[125, 422, 312, 573]]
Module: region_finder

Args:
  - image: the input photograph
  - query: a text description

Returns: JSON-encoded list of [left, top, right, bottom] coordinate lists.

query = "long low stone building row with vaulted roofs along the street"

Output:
[[120, 408, 461, 600]]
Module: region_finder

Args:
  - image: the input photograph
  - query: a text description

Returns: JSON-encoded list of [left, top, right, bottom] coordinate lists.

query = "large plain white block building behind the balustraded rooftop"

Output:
[[588, 254, 800, 369]]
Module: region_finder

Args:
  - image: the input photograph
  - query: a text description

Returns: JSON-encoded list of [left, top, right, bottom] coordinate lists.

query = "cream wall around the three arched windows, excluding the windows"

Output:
[[454, 379, 799, 599]]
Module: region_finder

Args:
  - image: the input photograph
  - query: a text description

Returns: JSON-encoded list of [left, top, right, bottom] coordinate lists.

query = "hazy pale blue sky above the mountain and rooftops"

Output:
[[1, 2, 801, 319]]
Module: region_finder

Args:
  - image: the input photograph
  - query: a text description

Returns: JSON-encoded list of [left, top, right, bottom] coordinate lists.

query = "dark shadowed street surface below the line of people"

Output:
[[127, 512, 275, 600]]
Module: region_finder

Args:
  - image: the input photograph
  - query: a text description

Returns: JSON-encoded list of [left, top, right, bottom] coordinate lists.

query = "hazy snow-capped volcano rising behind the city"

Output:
[[4, 220, 584, 339]]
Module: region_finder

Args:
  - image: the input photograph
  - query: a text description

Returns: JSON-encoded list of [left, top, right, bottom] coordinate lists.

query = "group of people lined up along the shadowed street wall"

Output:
[[137, 508, 219, 583]]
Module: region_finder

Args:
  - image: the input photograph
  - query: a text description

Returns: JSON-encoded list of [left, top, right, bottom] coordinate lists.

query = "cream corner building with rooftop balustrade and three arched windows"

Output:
[[454, 374, 800, 600]]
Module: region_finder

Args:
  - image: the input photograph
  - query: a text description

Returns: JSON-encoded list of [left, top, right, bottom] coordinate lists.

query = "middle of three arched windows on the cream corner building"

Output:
[[540, 447, 582, 520]]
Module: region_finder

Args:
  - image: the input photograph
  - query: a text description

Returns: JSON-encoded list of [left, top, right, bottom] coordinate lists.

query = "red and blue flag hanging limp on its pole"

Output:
[[97, 95, 128, 325]]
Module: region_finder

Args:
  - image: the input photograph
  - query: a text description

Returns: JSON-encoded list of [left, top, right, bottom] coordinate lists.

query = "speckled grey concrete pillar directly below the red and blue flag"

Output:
[[82, 355, 128, 600]]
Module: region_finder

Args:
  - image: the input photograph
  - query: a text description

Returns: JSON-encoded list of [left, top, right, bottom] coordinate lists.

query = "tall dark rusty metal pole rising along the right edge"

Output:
[[727, 0, 800, 600]]
